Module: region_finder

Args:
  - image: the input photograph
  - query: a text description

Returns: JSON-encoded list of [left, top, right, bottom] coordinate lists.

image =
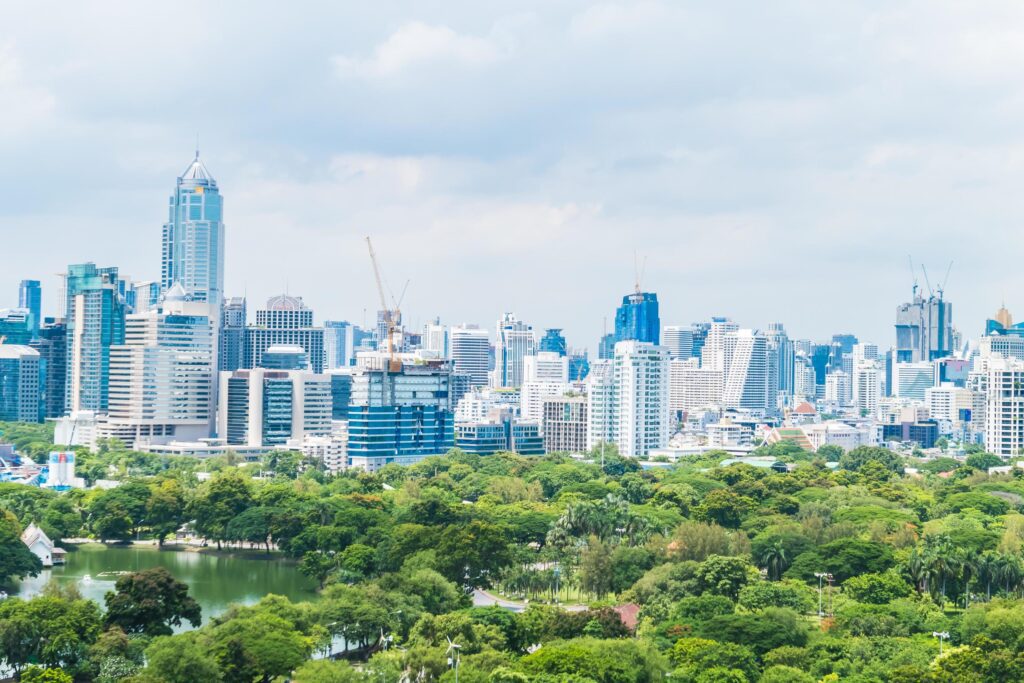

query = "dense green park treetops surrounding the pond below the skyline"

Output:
[[6, 428, 1024, 683]]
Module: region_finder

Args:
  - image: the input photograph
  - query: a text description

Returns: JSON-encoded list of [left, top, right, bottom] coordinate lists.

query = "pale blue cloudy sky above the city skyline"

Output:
[[0, 0, 1024, 349]]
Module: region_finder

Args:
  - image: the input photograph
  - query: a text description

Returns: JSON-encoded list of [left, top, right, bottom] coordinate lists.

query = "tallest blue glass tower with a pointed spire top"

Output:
[[160, 151, 224, 307]]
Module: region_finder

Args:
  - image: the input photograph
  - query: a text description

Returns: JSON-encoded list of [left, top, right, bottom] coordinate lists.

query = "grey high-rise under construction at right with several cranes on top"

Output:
[[896, 285, 953, 362]]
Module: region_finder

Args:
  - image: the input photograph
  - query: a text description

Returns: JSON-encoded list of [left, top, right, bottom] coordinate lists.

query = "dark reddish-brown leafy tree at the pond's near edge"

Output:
[[104, 567, 202, 636]]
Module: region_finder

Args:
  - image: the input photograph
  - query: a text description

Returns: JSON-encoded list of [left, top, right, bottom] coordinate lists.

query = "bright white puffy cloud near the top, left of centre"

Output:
[[333, 22, 505, 78]]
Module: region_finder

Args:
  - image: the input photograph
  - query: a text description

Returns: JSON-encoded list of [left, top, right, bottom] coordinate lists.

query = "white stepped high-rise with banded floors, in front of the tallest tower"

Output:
[[100, 283, 217, 449]]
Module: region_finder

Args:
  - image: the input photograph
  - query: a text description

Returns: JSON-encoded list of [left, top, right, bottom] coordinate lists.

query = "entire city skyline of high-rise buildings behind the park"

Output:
[[0, 153, 1024, 475]]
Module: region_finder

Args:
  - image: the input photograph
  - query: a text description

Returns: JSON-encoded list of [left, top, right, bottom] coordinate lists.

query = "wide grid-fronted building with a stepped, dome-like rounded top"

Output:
[[244, 294, 327, 374]]
